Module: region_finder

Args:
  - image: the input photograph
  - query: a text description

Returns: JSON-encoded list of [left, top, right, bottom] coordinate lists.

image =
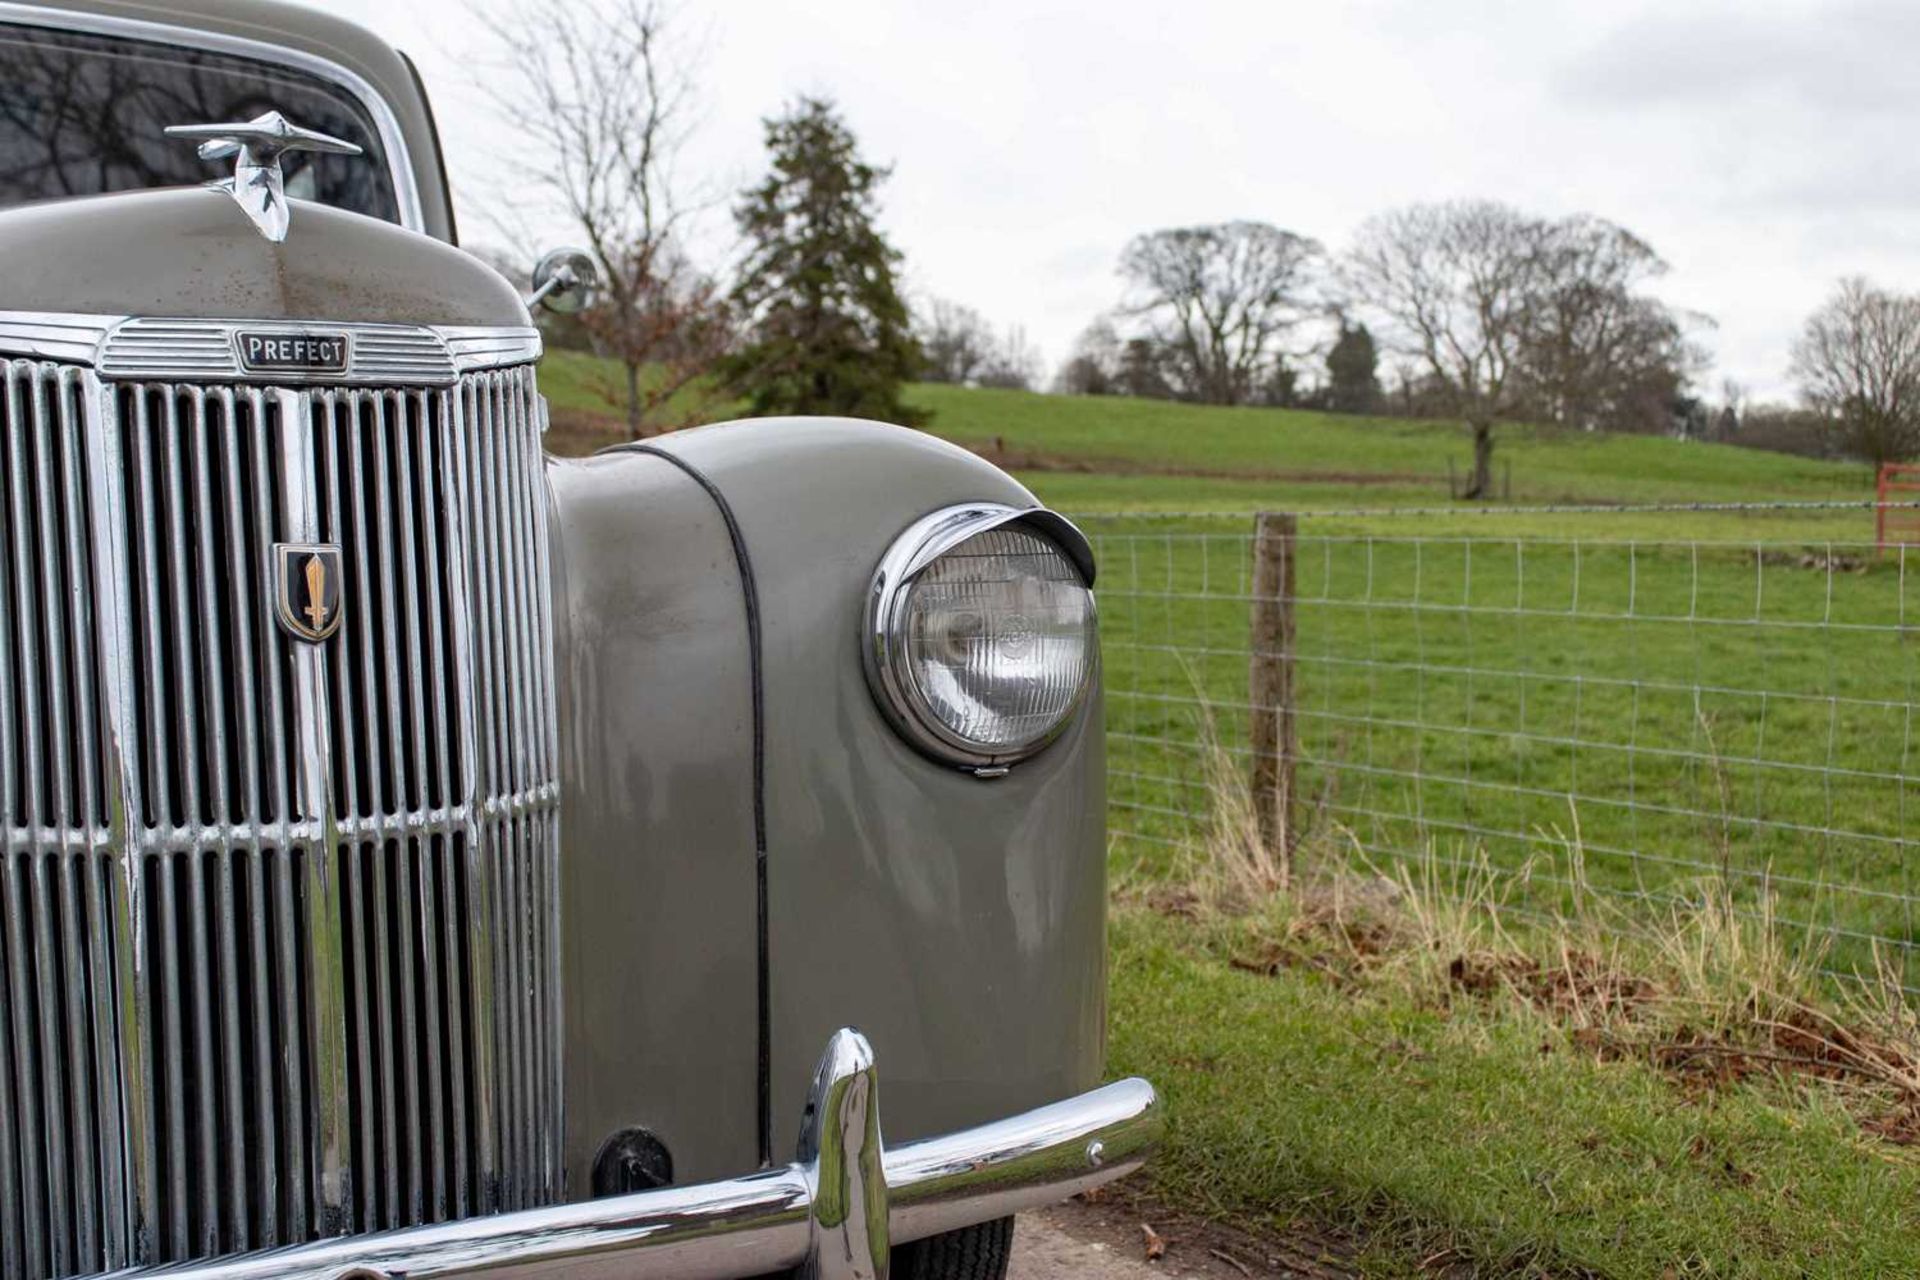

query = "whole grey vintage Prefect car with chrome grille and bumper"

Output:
[[0, 0, 1160, 1280]]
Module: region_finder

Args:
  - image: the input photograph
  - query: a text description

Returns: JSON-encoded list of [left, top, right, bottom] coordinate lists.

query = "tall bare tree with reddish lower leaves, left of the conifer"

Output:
[[474, 0, 732, 438]]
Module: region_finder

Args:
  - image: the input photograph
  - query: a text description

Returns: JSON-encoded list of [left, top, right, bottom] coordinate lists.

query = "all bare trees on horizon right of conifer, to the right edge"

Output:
[[1021, 214, 1920, 479]]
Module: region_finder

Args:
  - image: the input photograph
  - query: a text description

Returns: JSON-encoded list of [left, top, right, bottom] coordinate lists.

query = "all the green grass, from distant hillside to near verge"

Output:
[[529, 353, 1920, 1278]]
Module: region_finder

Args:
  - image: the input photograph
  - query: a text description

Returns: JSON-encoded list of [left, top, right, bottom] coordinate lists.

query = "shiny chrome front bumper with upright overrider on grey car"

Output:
[[121, 1031, 1162, 1280]]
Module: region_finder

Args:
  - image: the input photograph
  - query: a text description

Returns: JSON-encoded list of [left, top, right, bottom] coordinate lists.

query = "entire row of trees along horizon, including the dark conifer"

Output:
[[476, 0, 1920, 485]]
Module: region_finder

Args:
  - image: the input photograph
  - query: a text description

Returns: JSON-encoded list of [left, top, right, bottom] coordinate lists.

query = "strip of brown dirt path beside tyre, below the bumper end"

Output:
[[1008, 1201, 1359, 1280]]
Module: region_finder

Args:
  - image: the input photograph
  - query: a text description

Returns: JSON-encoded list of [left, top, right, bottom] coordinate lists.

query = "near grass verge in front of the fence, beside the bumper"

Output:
[[1112, 912, 1920, 1278]]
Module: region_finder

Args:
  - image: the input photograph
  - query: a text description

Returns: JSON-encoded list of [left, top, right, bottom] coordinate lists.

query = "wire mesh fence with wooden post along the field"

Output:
[[1089, 512, 1920, 984]]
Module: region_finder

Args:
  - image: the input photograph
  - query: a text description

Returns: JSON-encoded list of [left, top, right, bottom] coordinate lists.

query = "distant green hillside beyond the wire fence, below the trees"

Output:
[[541, 351, 1872, 537]]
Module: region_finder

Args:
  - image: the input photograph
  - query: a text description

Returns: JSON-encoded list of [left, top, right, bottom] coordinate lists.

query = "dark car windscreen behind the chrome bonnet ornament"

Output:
[[0, 23, 399, 223]]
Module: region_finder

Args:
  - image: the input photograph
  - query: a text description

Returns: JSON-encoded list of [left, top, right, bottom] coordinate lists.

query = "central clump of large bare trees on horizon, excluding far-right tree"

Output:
[[1036, 208, 1705, 497]]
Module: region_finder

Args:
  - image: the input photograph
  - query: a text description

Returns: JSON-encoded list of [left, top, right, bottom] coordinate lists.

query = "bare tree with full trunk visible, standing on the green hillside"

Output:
[[1342, 201, 1548, 497]]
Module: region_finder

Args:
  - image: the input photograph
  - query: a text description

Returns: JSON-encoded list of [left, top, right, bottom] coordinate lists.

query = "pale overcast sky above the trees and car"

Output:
[[332, 0, 1920, 397]]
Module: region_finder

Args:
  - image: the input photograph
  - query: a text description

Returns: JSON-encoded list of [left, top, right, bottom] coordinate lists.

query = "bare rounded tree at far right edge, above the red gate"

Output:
[[1793, 276, 1920, 466]]
